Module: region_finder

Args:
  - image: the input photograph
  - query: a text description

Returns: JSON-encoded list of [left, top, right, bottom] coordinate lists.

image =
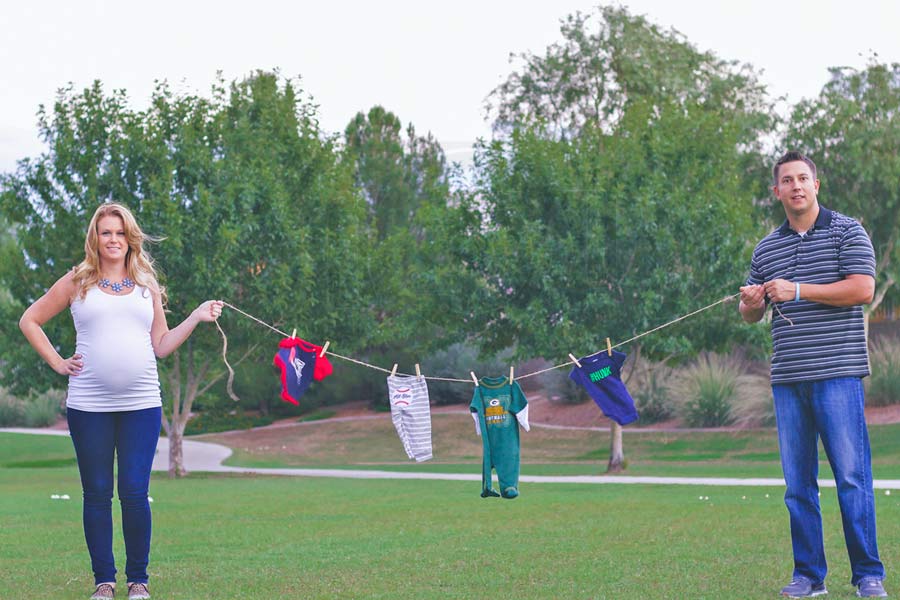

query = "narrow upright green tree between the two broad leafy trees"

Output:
[[344, 106, 450, 390]]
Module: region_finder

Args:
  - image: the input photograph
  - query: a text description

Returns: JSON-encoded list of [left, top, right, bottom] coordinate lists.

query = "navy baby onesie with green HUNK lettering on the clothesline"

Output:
[[569, 350, 638, 425]]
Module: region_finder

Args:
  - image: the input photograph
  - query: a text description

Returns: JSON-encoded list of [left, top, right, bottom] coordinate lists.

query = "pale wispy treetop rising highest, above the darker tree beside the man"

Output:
[[486, 6, 770, 145]]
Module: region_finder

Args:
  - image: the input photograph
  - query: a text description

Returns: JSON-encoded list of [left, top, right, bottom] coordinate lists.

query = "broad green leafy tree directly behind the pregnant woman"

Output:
[[0, 72, 371, 475]]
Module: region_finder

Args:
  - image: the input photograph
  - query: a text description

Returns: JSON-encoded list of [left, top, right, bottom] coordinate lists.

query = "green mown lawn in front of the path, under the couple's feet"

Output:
[[0, 434, 900, 600]]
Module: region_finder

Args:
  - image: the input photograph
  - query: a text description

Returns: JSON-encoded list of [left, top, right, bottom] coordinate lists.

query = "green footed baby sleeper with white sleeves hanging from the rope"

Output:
[[469, 377, 530, 498]]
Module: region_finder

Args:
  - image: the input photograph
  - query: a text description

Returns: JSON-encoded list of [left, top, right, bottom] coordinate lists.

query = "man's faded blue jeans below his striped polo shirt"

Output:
[[772, 377, 884, 585]]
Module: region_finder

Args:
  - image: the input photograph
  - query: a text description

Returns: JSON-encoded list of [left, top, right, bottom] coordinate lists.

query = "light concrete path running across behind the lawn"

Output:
[[0, 429, 900, 490]]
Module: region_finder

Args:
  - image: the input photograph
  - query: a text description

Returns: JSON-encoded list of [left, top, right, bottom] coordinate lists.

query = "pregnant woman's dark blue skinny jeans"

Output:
[[66, 408, 162, 583]]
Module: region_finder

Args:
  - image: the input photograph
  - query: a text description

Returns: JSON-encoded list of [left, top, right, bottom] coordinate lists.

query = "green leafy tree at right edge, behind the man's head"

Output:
[[773, 57, 900, 312]]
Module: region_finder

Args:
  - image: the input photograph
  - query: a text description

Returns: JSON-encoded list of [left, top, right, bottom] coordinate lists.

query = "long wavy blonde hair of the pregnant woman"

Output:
[[73, 202, 167, 305]]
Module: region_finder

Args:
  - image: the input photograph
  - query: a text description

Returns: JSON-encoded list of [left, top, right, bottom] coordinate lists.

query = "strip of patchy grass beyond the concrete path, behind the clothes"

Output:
[[204, 413, 900, 479]]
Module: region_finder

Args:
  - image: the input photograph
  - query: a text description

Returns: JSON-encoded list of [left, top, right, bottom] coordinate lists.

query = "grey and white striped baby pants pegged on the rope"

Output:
[[387, 375, 431, 462]]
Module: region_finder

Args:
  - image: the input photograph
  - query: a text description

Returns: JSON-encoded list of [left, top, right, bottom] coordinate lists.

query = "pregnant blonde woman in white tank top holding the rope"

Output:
[[19, 203, 222, 600]]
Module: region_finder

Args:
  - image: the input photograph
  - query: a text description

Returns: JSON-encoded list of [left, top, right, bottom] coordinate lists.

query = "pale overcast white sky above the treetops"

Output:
[[0, 0, 900, 172]]
